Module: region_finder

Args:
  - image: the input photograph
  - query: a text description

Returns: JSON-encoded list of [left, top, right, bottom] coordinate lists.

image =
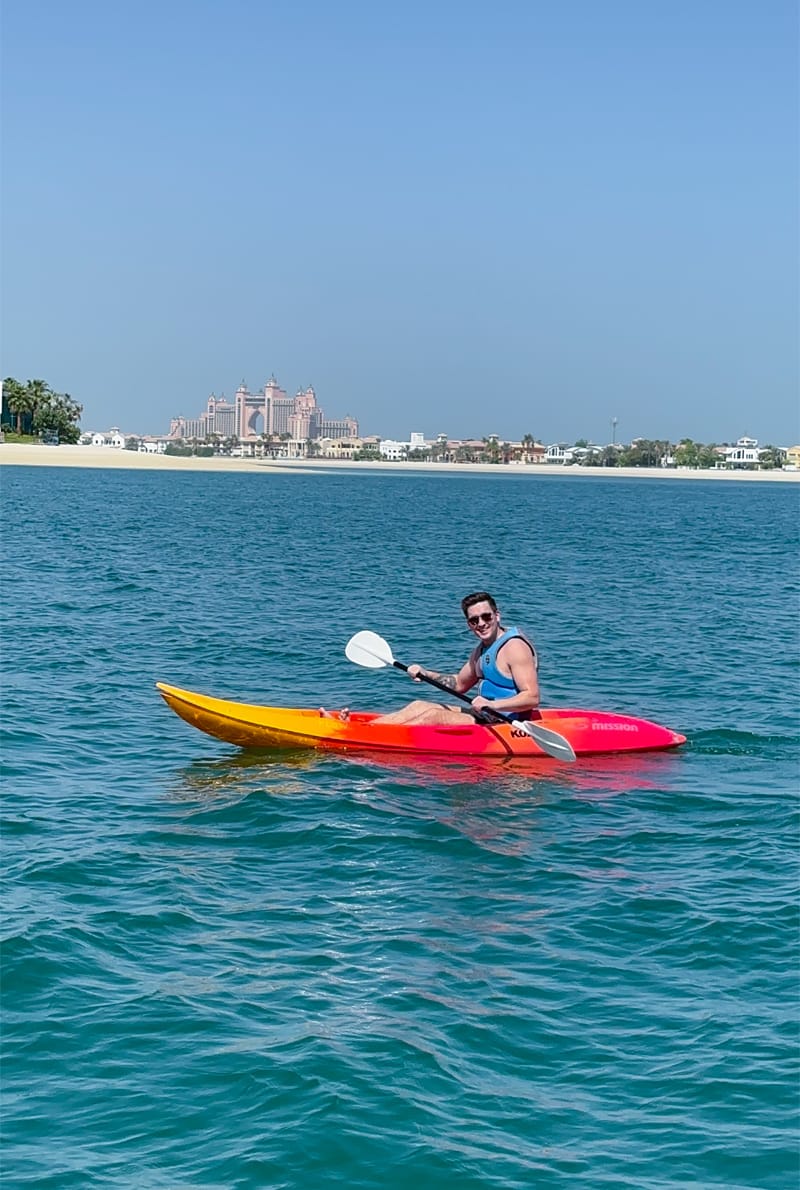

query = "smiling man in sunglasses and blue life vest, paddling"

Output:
[[375, 591, 539, 724]]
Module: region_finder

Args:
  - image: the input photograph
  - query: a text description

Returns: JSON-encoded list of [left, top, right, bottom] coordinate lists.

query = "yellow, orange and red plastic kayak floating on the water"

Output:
[[156, 682, 686, 758]]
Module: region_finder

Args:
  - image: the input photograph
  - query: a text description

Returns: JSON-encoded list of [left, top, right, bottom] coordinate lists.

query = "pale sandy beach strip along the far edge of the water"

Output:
[[0, 443, 800, 483]]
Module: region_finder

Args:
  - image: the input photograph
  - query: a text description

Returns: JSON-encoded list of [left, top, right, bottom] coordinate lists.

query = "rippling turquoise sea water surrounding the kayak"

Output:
[[1, 468, 800, 1190]]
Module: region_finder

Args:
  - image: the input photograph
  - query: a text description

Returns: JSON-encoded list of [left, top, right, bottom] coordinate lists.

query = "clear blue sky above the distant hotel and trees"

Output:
[[2, 0, 800, 445]]
